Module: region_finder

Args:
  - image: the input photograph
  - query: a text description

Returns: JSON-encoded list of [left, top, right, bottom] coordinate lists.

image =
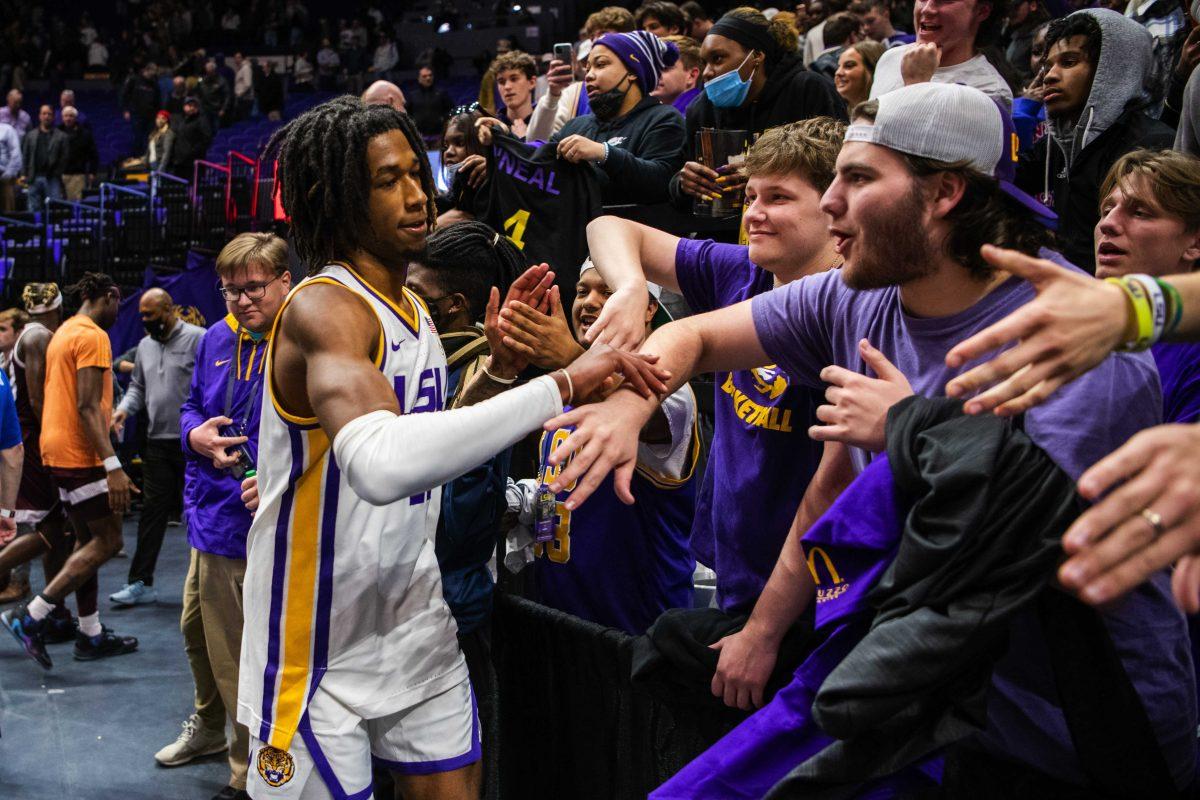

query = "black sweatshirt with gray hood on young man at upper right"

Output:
[[1016, 8, 1175, 273]]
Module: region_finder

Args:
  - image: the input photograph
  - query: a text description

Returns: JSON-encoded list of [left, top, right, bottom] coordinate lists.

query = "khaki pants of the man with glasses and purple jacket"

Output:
[[179, 548, 250, 789]]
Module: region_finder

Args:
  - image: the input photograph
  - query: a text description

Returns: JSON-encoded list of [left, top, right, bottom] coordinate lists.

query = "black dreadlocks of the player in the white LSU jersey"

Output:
[[266, 95, 437, 272]]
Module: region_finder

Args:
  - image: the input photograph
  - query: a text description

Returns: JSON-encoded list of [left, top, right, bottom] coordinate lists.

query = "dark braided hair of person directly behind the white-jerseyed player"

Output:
[[425, 222, 526, 323]]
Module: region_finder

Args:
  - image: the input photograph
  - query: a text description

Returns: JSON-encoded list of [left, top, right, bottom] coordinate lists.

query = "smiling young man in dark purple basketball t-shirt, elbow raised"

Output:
[[588, 120, 850, 709]]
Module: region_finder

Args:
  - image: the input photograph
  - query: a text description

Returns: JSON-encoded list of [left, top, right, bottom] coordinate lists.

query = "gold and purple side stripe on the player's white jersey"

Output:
[[258, 427, 341, 750]]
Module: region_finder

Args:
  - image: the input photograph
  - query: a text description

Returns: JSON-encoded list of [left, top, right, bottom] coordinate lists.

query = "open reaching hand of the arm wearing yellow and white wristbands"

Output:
[[946, 245, 1132, 416]]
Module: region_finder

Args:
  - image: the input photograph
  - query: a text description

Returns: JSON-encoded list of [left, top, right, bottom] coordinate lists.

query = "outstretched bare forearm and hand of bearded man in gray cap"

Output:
[[546, 300, 770, 510]]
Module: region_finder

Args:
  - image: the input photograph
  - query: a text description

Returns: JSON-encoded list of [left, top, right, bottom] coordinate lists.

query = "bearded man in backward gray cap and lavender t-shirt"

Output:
[[552, 84, 1196, 796]]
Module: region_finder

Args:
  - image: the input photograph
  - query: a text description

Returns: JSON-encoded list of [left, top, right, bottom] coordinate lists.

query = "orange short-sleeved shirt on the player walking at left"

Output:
[[41, 314, 113, 469]]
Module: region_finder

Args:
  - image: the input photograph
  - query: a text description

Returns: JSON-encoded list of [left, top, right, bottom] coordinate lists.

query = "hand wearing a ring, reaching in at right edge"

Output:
[[1058, 425, 1200, 604]]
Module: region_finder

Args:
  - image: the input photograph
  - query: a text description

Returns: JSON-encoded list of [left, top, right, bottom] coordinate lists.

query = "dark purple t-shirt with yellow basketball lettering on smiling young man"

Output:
[[676, 239, 824, 613]]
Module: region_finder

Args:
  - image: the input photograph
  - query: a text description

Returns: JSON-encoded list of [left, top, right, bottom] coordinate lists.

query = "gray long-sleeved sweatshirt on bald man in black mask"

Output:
[[118, 319, 204, 439]]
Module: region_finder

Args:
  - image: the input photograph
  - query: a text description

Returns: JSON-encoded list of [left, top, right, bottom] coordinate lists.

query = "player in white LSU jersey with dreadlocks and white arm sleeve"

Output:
[[238, 96, 665, 800]]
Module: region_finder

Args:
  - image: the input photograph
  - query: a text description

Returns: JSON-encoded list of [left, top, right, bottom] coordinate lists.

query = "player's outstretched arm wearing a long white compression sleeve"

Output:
[[284, 285, 666, 505]]
